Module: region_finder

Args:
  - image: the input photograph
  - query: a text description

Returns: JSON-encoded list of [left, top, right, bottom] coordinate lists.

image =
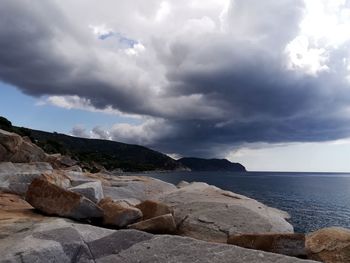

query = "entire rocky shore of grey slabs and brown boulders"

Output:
[[0, 130, 350, 263]]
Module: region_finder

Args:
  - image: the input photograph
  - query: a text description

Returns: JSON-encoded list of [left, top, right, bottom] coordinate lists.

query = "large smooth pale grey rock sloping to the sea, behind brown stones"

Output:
[[160, 183, 293, 243]]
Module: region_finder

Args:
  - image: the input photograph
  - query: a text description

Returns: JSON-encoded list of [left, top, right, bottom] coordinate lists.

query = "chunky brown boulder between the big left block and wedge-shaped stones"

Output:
[[98, 198, 142, 228]]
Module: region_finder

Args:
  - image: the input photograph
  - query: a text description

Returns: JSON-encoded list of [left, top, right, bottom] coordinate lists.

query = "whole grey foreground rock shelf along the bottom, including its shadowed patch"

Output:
[[0, 218, 318, 263]]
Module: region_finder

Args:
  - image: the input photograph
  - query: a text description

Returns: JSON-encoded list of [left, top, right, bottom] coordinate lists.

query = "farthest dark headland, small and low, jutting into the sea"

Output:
[[178, 157, 246, 172]]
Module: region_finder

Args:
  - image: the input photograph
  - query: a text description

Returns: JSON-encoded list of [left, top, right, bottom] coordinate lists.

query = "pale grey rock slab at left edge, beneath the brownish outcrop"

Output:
[[0, 162, 53, 195]]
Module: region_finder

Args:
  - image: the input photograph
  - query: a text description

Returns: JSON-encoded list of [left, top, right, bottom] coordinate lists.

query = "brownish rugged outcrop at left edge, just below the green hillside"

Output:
[[0, 129, 47, 163]]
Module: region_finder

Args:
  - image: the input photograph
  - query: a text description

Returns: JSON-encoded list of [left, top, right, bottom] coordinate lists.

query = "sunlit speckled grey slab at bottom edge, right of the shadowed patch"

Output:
[[96, 235, 313, 263]]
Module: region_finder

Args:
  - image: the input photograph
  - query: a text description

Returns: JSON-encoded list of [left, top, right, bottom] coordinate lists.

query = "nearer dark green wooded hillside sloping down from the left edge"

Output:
[[0, 117, 184, 172]]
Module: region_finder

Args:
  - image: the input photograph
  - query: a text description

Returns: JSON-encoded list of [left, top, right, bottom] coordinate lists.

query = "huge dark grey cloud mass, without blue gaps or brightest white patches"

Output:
[[0, 0, 350, 156]]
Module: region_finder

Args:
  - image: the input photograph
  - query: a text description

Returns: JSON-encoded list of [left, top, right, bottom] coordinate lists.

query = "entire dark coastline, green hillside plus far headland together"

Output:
[[0, 116, 245, 172]]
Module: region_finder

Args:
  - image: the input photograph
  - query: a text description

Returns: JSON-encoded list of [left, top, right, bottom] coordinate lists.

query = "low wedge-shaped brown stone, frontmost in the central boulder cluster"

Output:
[[128, 214, 176, 234]]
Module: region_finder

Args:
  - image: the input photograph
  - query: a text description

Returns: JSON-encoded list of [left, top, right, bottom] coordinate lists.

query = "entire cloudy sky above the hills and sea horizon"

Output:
[[0, 0, 350, 172]]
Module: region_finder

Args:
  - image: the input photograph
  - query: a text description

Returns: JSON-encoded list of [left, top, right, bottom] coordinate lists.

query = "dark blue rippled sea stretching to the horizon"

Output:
[[146, 172, 350, 233]]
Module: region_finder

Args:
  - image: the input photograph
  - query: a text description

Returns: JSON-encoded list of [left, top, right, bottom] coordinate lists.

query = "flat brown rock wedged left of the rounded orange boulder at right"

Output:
[[227, 233, 306, 258]]
